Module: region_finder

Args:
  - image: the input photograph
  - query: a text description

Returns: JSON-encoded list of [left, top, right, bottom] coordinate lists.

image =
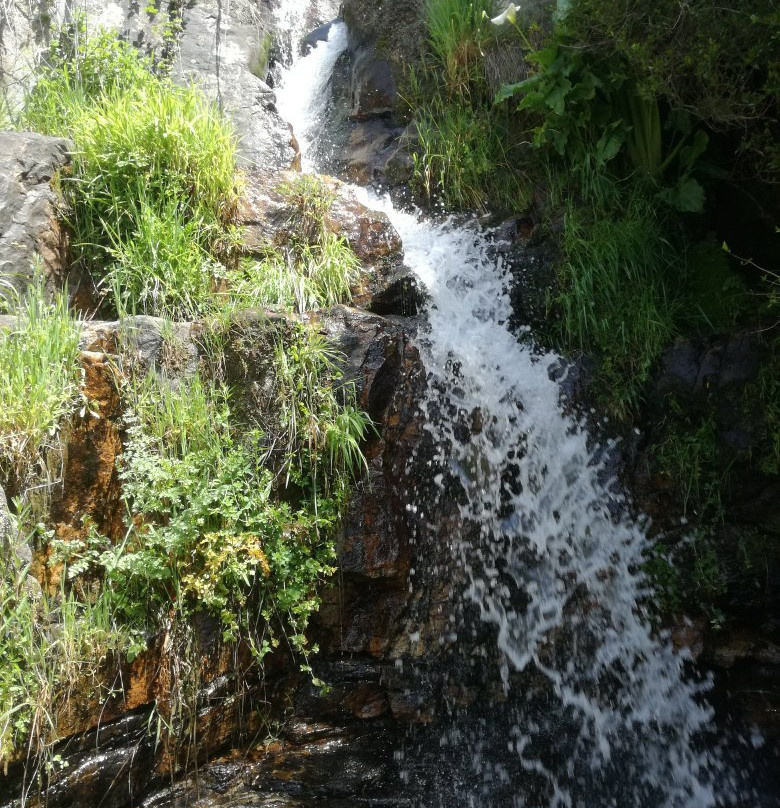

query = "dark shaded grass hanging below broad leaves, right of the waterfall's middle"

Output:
[[554, 188, 681, 419]]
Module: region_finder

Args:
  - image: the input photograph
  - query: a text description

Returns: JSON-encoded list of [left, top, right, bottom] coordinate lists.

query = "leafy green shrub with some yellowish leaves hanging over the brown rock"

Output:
[[98, 318, 367, 659]]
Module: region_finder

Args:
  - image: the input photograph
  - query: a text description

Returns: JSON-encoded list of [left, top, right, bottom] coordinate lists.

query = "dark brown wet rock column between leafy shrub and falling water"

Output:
[[315, 307, 455, 660]]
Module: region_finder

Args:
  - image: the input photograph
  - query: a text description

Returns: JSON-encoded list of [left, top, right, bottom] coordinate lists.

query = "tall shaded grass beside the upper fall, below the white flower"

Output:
[[407, 0, 532, 212]]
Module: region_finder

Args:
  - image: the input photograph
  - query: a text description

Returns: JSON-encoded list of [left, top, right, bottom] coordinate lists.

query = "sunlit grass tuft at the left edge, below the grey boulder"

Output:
[[0, 280, 80, 493]]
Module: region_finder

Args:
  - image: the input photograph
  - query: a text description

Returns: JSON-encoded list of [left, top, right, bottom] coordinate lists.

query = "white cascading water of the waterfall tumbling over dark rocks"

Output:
[[272, 12, 748, 808]]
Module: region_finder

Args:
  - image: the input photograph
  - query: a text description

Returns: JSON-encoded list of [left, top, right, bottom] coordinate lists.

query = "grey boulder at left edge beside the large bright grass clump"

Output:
[[0, 132, 70, 303]]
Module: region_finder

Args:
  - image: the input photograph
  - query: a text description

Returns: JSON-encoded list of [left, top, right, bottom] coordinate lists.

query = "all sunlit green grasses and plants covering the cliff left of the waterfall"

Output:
[[0, 23, 370, 789]]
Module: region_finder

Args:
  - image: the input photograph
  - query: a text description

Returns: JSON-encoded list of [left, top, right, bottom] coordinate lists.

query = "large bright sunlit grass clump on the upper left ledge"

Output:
[[23, 25, 238, 316]]
